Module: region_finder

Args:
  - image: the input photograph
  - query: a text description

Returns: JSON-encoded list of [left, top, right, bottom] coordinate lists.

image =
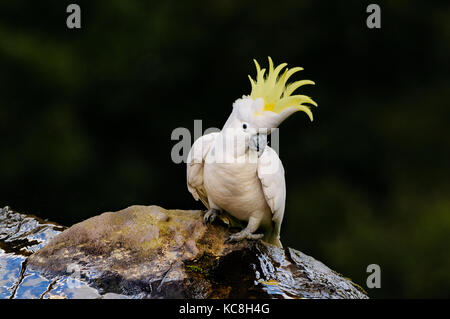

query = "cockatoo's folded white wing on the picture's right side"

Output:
[[258, 146, 286, 242]]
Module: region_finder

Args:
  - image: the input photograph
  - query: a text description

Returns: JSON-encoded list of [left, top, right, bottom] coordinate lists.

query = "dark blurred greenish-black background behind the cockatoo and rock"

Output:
[[0, 0, 450, 298]]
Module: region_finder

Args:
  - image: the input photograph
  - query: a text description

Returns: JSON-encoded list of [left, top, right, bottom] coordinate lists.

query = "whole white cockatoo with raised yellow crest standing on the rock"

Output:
[[187, 57, 317, 247]]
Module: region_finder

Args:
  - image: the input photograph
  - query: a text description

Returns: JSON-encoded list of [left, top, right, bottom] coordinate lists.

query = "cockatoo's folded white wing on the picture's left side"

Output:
[[187, 132, 219, 209]]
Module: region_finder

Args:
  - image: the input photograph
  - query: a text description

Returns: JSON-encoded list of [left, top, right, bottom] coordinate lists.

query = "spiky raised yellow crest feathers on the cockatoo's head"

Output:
[[248, 57, 317, 121]]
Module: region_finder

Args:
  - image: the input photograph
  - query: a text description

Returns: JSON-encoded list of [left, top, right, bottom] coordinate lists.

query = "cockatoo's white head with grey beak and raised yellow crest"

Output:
[[224, 57, 317, 158]]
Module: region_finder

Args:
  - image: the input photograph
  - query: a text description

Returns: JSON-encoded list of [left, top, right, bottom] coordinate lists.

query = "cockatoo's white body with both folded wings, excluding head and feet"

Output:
[[187, 132, 286, 247]]
